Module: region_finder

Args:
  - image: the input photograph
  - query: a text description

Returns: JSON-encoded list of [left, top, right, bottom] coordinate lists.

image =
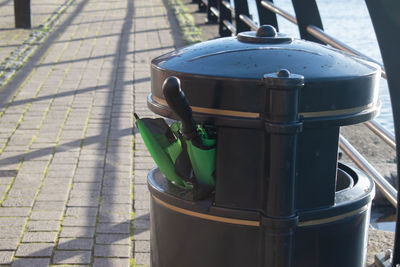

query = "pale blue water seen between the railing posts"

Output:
[[244, 0, 394, 133]]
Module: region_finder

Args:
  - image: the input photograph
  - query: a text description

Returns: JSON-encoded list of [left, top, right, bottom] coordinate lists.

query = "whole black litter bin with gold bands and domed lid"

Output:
[[148, 26, 380, 267]]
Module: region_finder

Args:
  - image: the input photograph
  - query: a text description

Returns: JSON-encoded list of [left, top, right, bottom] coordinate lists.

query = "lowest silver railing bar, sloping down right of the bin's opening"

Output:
[[339, 136, 397, 207]]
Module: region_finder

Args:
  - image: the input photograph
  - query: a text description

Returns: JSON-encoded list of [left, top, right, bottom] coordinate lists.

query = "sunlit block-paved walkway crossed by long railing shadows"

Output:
[[0, 0, 180, 267]]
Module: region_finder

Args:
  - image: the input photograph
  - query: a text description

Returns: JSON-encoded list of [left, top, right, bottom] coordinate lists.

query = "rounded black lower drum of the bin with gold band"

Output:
[[148, 164, 374, 267]]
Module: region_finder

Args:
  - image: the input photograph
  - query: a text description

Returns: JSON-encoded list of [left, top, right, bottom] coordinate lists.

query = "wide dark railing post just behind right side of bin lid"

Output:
[[292, 0, 324, 44]]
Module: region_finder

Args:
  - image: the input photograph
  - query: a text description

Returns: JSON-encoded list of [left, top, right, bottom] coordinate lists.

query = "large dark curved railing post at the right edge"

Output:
[[365, 0, 400, 266]]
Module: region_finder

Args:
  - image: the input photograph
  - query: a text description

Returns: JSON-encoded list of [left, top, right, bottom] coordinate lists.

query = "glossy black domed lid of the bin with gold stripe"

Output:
[[148, 26, 381, 125]]
